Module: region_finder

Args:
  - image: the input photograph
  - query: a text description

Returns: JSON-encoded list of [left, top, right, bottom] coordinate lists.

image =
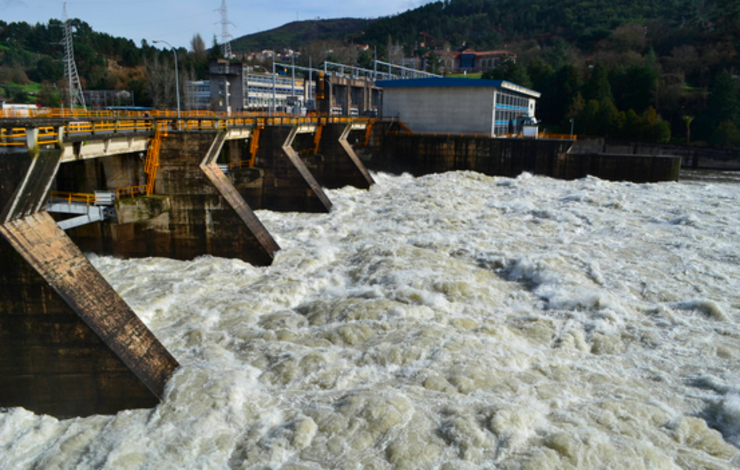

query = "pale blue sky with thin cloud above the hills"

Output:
[[0, 0, 424, 49]]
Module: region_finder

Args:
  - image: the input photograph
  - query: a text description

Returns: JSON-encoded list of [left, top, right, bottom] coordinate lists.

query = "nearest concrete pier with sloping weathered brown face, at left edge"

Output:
[[0, 148, 178, 418]]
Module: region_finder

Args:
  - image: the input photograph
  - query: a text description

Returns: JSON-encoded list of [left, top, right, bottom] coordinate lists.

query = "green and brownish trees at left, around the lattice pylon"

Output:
[[0, 19, 207, 106]]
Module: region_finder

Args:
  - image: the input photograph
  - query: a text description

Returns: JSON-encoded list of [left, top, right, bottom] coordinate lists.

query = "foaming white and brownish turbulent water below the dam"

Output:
[[0, 172, 740, 470]]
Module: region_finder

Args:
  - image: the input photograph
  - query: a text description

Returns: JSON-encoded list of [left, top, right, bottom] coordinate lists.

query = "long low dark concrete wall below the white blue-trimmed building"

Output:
[[363, 129, 681, 183]]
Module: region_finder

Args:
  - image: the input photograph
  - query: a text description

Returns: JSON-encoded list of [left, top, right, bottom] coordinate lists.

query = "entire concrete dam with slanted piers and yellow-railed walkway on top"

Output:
[[0, 111, 680, 418]]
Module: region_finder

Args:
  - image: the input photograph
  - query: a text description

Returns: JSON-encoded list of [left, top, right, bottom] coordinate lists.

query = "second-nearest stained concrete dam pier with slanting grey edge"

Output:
[[65, 131, 280, 266]]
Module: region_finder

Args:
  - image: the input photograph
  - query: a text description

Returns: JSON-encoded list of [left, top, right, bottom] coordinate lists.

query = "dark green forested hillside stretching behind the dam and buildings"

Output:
[[0, 0, 740, 147]]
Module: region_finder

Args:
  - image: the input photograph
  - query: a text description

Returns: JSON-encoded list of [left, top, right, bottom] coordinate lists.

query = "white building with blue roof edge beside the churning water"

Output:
[[377, 78, 540, 137]]
